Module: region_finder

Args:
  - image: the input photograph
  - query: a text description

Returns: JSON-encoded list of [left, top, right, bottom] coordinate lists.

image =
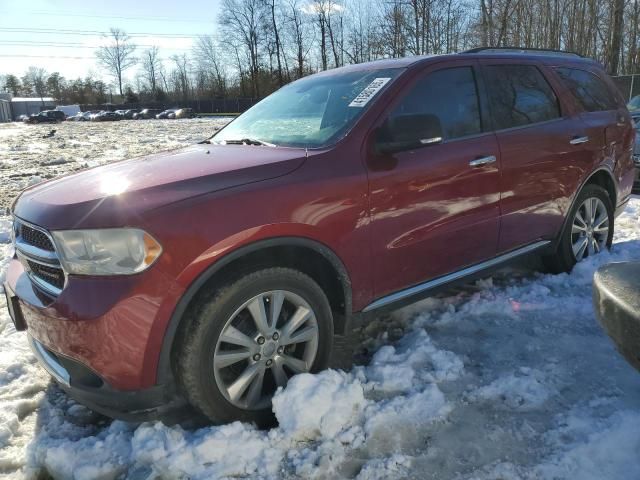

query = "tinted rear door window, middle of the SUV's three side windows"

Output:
[[485, 65, 561, 130]]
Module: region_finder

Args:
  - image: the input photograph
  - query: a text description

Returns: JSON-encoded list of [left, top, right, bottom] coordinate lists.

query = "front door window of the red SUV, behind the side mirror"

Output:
[[389, 67, 482, 140]]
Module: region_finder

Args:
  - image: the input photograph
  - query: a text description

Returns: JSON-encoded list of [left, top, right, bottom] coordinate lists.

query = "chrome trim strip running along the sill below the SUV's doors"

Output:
[[362, 240, 551, 312]]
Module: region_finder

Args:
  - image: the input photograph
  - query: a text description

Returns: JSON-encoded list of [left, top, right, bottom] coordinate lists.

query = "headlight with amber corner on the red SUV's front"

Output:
[[52, 228, 162, 275]]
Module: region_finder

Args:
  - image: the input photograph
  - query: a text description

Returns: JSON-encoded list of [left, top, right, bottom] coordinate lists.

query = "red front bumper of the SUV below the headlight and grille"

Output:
[[6, 249, 181, 392]]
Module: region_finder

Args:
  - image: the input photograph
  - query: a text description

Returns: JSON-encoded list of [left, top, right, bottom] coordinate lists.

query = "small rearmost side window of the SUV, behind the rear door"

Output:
[[555, 67, 618, 112]]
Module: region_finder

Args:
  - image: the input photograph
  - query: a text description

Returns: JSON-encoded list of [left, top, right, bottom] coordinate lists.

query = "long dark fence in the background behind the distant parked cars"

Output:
[[80, 98, 258, 114]]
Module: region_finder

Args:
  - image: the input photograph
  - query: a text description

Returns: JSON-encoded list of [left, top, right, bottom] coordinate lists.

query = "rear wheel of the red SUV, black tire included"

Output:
[[543, 184, 614, 273]]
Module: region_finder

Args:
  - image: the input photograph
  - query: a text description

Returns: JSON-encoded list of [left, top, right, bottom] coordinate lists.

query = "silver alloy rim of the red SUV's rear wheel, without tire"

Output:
[[571, 197, 609, 262]]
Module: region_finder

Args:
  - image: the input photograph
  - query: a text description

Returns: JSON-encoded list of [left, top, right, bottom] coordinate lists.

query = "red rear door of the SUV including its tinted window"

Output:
[[481, 59, 590, 252]]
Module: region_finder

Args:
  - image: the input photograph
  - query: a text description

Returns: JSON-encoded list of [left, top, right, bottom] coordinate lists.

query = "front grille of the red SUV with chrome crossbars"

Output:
[[14, 217, 67, 296]]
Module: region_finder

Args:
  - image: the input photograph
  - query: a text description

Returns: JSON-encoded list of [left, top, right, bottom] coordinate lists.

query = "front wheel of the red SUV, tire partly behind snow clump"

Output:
[[174, 268, 333, 426]]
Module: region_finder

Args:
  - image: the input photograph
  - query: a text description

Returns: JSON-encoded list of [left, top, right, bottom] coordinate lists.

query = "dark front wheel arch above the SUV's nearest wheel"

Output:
[[156, 237, 352, 384]]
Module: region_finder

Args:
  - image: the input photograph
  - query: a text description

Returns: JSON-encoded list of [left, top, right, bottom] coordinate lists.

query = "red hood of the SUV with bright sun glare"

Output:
[[14, 144, 305, 230]]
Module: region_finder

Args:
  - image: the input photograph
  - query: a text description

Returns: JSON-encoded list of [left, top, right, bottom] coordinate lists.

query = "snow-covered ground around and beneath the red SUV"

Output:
[[0, 121, 640, 480]]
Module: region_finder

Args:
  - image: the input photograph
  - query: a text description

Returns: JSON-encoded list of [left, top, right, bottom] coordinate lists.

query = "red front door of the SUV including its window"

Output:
[[366, 60, 500, 297]]
